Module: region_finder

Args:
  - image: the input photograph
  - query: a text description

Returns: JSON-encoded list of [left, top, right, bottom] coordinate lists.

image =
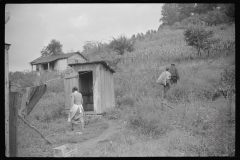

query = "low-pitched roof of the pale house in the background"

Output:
[[30, 52, 87, 65]]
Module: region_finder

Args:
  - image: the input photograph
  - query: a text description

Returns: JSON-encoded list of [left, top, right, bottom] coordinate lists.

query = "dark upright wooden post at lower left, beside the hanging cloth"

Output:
[[9, 92, 22, 157]]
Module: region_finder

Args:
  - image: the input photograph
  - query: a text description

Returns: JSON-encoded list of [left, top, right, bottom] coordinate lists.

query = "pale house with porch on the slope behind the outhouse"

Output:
[[30, 52, 87, 72]]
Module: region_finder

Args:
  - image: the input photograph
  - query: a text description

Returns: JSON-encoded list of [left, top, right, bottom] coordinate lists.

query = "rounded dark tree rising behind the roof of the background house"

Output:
[[41, 39, 63, 57]]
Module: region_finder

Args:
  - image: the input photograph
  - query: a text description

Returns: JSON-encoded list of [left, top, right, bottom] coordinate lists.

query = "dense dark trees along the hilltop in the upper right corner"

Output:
[[160, 3, 235, 28]]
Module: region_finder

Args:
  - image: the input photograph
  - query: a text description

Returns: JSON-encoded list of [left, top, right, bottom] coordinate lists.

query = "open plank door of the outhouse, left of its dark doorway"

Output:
[[64, 73, 79, 109]]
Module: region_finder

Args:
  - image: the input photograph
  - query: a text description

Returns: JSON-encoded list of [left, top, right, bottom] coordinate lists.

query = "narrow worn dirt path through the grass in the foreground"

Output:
[[76, 118, 124, 157]]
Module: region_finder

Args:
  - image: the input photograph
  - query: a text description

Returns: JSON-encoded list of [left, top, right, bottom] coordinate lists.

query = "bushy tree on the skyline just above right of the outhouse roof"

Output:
[[108, 35, 135, 55]]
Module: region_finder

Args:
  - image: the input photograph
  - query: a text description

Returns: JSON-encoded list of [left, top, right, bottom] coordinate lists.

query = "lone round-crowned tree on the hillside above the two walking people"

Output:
[[184, 26, 216, 57]]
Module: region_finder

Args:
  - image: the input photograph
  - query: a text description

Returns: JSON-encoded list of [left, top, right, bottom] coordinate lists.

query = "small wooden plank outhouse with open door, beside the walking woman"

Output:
[[64, 61, 115, 114]]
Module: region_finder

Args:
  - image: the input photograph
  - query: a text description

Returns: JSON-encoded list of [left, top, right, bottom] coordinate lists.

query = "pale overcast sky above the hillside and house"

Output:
[[5, 3, 163, 71]]
